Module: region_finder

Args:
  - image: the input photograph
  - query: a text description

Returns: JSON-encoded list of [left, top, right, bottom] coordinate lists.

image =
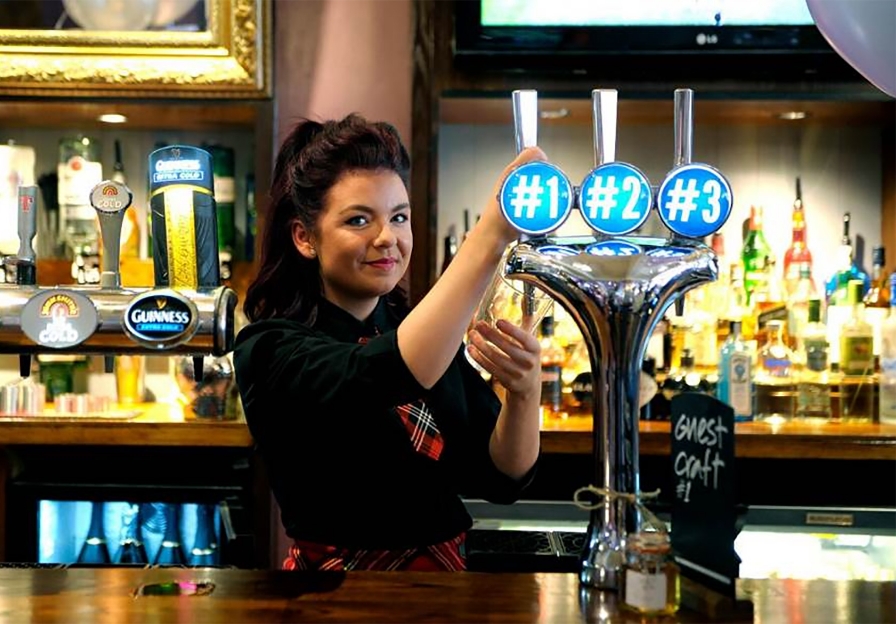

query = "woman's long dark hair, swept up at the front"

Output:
[[243, 113, 410, 323]]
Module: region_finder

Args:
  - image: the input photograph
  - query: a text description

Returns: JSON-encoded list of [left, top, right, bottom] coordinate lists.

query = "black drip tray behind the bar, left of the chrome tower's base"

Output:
[[465, 529, 587, 572]]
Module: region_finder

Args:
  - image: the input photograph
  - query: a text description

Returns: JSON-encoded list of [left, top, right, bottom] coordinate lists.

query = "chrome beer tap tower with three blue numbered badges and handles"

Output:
[[499, 89, 732, 589]]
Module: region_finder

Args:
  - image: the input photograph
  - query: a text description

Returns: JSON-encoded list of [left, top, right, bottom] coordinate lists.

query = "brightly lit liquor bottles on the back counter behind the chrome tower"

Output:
[[528, 180, 896, 424]]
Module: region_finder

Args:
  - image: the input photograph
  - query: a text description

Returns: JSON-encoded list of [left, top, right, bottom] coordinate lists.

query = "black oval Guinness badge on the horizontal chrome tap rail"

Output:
[[124, 290, 199, 349]]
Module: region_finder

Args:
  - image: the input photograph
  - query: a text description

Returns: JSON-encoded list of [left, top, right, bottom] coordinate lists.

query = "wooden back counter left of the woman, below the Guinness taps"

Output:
[[0, 403, 252, 447]]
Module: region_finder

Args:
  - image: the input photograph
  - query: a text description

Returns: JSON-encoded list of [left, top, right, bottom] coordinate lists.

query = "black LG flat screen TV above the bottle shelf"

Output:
[[454, 0, 860, 81]]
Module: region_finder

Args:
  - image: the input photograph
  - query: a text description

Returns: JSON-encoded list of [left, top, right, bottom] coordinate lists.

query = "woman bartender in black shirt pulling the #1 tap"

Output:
[[234, 114, 545, 570]]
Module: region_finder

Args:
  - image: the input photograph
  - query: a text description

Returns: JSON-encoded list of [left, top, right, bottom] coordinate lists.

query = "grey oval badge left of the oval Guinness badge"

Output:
[[19, 288, 98, 349]]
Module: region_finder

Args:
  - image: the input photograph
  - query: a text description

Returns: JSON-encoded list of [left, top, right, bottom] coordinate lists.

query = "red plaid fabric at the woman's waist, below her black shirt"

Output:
[[283, 533, 467, 572]]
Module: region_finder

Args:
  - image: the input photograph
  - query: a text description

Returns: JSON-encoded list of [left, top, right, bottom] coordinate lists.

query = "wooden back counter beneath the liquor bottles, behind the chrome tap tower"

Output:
[[541, 416, 896, 461]]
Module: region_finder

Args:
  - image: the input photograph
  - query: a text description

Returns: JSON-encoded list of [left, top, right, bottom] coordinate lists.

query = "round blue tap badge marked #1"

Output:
[[498, 162, 575, 234]]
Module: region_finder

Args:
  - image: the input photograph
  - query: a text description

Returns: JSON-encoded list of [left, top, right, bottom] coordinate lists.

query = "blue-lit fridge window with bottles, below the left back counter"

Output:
[[38, 500, 226, 566]]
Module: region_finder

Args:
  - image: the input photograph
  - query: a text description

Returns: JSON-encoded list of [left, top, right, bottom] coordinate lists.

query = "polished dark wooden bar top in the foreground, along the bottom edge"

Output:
[[0, 568, 896, 624]]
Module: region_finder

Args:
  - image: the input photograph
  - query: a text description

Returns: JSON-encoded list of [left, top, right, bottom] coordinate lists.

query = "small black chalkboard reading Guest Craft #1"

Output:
[[671, 393, 740, 598]]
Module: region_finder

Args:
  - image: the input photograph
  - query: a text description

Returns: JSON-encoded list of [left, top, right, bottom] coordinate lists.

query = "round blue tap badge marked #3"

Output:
[[657, 163, 734, 238]]
